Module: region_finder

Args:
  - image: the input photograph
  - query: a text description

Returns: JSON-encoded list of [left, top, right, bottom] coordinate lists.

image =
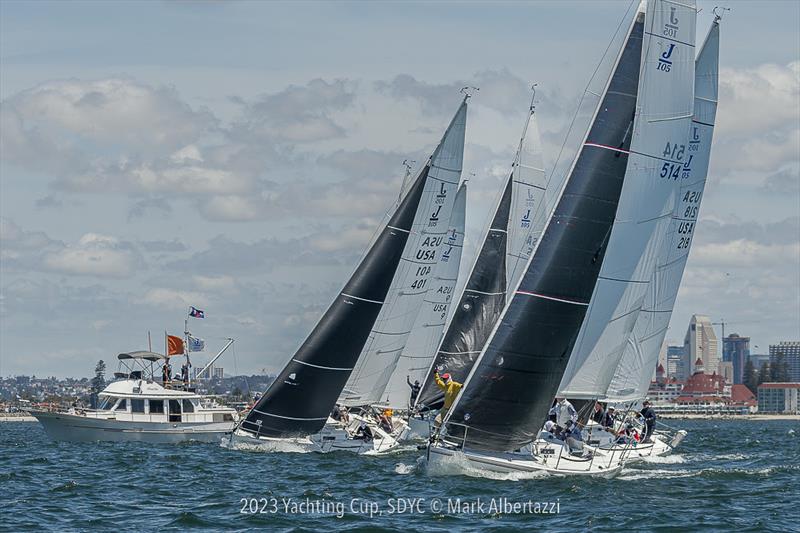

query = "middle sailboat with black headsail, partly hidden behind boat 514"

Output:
[[409, 86, 546, 439]]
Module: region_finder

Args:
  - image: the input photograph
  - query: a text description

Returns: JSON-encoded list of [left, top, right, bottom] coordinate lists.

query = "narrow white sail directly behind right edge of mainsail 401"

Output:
[[382, 183, 467, 409]]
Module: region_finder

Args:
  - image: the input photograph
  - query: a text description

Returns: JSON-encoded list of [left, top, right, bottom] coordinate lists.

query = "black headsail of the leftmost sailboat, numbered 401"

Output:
[[239, 100, 466, 438]]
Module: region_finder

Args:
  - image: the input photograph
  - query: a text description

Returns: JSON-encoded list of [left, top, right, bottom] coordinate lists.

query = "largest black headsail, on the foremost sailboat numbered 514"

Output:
[[445, 13, 644, 451]]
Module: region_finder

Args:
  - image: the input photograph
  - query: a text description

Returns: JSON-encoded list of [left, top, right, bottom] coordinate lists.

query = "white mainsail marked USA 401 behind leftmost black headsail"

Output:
[[340, 98, 467, 406]]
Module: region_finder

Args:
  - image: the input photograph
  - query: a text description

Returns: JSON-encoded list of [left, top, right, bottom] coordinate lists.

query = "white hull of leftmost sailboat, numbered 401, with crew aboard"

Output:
[[227, 415, 407, 455]]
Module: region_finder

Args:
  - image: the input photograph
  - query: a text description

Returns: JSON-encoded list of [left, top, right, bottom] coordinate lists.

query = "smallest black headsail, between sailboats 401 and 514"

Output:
[[417, 174, 513, 409]]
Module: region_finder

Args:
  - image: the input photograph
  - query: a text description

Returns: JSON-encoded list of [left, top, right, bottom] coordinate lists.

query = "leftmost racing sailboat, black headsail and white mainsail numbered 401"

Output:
[[227, 95, 469, 453]]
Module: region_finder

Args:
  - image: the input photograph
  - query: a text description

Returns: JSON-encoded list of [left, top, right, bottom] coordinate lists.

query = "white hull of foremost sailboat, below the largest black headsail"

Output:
[[428, 441, 623, 477]]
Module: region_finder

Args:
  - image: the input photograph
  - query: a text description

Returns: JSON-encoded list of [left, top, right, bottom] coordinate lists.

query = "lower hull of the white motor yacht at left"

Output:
[[31, 411, 234, 443]]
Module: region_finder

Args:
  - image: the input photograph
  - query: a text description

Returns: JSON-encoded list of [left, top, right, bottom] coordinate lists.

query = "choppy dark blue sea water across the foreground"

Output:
[[0, 420, 800, 532]]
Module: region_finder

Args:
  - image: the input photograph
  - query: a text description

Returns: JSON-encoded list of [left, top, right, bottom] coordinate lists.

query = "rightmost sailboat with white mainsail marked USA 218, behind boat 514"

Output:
[[589, 15, 721, 460]]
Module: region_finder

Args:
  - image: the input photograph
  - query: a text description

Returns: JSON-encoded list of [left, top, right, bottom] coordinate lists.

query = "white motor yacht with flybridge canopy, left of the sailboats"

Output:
[[31, 341, 238, 443]]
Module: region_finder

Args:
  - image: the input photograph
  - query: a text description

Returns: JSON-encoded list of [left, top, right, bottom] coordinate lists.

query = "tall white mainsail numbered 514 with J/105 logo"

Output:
[[559, 0, 697, 399]]
